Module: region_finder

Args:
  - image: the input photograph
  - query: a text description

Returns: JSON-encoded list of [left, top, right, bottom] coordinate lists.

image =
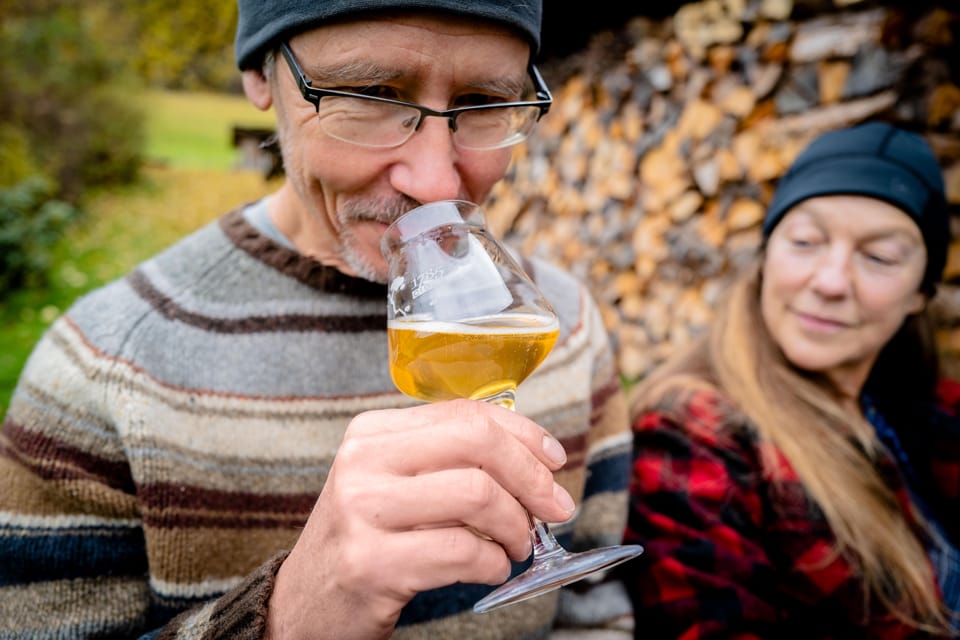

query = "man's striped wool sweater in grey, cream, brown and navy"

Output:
[[0, 210, 630, 639]]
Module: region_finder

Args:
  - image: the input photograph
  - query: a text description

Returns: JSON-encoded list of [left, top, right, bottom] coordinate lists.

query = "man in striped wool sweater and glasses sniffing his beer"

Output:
[[0, 0, 629, 638]]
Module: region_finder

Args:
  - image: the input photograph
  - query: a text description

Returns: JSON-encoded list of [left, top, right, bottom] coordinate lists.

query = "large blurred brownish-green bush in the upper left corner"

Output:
[[0, 2, 143, 201]]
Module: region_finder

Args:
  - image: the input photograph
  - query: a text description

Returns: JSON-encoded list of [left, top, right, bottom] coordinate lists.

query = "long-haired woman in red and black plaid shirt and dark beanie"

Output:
[[626, 123, 960, 639]]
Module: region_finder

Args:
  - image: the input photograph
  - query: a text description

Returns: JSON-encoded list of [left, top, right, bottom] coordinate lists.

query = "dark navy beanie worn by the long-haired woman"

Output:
[[763, 122, 950, 287]]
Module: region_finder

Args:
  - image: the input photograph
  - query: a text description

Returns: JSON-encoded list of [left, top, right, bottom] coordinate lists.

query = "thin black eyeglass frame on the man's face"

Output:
[[280, 42, 553, 148]]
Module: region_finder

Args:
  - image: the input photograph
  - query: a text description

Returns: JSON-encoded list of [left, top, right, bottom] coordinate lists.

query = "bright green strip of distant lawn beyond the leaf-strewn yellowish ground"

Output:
[[143, 91, 274, 169]]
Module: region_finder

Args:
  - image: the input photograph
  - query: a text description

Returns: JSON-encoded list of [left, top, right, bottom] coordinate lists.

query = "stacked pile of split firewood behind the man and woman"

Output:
[[488, 0, 960, 380]]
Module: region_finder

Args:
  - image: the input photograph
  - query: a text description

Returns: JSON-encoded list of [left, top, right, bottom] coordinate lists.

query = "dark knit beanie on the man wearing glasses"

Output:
[[234, 0, 543, 70]]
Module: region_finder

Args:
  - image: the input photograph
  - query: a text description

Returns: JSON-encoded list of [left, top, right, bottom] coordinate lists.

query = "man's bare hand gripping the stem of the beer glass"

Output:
[[268, 400, 574, 639]]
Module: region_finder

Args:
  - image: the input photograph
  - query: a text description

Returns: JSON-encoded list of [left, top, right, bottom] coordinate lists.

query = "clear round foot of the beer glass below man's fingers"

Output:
[[473, 544, 643, 613]]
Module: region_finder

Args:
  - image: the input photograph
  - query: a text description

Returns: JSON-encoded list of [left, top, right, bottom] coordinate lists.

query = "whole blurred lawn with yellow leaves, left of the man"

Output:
[[0, 92, 277, 415]]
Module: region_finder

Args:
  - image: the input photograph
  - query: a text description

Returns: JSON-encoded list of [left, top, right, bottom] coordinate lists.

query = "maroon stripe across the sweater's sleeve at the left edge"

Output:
[[0, 418, 134, 493]]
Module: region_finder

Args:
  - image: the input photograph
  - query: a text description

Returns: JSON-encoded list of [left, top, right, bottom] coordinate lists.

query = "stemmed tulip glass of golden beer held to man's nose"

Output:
[[381, 200, 643, 613]]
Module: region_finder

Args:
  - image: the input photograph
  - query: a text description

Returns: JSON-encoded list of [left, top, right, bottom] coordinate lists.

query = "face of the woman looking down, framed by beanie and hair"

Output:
[[760, 195, 927, 396]]
